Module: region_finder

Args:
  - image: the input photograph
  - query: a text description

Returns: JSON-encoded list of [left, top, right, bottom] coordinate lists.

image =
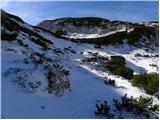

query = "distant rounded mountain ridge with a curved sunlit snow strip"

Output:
[[37, 17, 158, 45]]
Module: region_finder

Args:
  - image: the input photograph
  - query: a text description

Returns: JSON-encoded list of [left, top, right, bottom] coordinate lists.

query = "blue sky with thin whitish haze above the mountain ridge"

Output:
[[2, 1, 158, 25]]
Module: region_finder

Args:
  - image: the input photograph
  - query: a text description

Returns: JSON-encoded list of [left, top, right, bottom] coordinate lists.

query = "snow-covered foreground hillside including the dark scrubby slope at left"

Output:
[[1, 11, 159, 118]]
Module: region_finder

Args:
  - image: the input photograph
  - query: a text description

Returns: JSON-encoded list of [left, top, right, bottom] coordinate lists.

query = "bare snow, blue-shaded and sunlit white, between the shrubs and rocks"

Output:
[[2, 19, 159, 119]]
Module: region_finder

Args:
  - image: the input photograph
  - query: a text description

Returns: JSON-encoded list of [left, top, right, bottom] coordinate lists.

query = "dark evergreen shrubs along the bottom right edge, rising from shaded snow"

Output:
[[95, 94, 159, 119]]
